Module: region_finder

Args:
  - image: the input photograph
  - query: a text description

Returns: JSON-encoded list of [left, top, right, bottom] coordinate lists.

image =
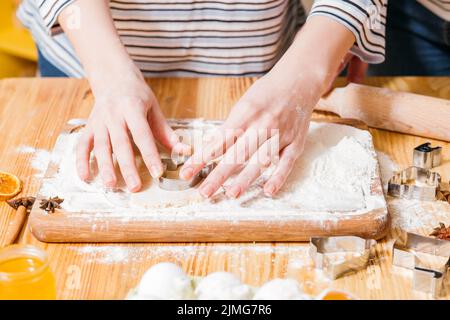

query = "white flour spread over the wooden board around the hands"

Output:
[[37, 121, 385, 220]]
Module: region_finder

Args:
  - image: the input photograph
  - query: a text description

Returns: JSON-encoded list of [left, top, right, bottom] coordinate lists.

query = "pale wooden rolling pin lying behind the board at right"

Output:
[[315, 83, 450, 141]]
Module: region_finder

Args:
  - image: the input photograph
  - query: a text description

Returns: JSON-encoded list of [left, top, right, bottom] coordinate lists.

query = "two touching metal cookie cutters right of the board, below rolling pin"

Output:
[[388, 142, 442, 201]]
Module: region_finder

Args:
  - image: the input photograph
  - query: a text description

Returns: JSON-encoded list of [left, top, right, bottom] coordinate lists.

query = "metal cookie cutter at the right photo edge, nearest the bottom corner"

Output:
[[392, 232, 450, 297]]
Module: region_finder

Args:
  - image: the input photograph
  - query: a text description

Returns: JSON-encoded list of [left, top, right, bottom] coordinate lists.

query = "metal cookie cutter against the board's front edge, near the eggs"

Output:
[[309, 236, 377, 279]]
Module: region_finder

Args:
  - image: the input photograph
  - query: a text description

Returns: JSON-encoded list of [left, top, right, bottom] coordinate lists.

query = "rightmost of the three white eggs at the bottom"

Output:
[[253, 279, 311, 300]]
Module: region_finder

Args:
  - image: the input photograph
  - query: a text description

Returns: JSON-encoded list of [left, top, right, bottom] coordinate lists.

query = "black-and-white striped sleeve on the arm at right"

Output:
[[309, 0, 388, 63]]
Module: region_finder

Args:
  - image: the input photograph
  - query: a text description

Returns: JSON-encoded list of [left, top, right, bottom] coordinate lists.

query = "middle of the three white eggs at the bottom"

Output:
[[195, 272, 252, 300]]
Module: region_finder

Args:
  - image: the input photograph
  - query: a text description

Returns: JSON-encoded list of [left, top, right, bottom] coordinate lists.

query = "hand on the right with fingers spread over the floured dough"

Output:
[[180, 73, 312, 198]]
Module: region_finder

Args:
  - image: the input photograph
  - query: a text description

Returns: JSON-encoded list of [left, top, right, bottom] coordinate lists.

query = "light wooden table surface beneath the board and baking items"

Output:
[[0, 77, 450, 299]]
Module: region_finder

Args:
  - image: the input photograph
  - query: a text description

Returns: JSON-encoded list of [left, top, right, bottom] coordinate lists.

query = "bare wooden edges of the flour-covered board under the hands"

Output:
[[29, 119, 390, 242]]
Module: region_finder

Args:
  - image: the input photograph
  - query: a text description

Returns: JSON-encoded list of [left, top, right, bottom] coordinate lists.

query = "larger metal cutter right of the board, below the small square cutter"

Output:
[[388, 167, 441, 200]]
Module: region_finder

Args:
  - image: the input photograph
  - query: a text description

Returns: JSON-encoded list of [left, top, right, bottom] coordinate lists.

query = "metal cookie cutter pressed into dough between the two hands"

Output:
[[158, 157, 216, 191]]
